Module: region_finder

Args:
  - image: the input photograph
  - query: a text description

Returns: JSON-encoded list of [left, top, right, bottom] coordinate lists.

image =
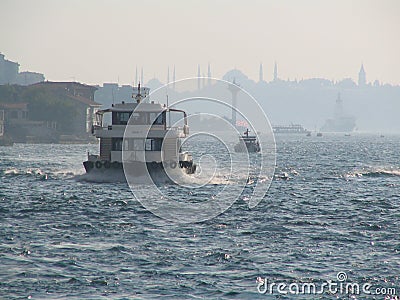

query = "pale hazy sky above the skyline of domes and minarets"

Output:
[[0, 0, 400, 84]]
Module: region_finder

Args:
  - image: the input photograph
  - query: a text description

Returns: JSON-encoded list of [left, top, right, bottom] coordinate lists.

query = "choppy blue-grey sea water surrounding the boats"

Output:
[[0, 135, 400, 299]]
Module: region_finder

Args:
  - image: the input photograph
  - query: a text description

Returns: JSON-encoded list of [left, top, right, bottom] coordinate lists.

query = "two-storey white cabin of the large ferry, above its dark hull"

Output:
[[93, 102, 189, 163]]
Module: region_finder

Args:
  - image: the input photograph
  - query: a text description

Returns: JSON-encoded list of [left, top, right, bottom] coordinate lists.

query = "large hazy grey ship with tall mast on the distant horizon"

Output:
[[321, 93, 356, 132]]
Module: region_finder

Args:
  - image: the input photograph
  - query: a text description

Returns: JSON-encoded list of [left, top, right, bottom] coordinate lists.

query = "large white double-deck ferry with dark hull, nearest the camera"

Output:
[[83, 84, 196, 178]]
